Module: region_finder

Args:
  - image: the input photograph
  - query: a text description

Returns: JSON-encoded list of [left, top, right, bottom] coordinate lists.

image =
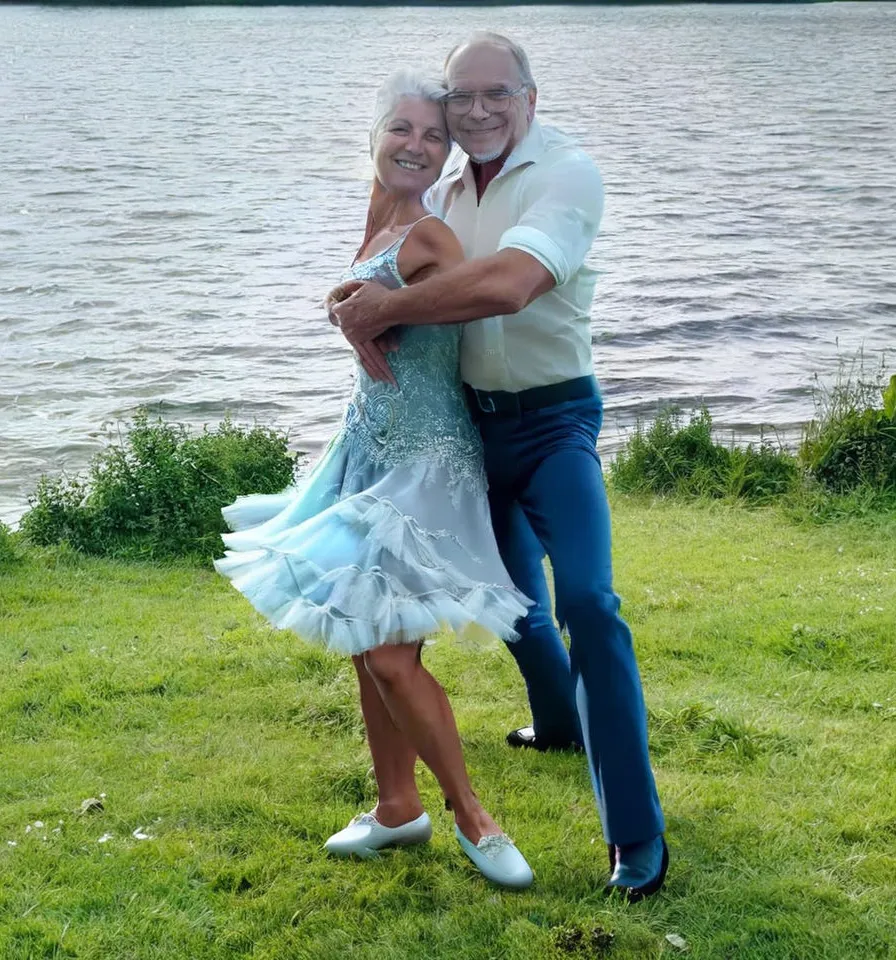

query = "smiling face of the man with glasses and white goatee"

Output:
[[445, 44, 535, 163]]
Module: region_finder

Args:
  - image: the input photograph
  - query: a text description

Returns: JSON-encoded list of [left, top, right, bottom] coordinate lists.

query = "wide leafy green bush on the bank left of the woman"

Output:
[[22, 411, 296, 559]]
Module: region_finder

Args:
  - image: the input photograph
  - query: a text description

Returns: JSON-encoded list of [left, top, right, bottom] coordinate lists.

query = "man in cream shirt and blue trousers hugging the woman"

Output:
[[331, 33, 668, 900]]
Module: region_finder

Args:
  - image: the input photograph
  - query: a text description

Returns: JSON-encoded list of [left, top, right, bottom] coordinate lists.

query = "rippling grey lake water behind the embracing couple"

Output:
[[0, 3, 896, 521]]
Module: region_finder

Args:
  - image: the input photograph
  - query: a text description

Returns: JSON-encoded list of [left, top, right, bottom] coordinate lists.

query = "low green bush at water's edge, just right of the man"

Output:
[[610, 408, 799, 503]]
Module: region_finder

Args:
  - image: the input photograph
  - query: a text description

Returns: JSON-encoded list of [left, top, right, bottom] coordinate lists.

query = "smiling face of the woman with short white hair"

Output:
[[373, 97, 450, 196]]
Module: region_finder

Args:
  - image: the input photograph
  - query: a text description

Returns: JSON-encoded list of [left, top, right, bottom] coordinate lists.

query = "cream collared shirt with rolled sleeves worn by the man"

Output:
[[427, 120, 604, 393]]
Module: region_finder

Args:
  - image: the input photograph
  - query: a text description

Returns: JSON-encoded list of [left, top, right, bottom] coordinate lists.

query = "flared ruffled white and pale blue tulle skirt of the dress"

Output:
[[215, 445, 530, 654]]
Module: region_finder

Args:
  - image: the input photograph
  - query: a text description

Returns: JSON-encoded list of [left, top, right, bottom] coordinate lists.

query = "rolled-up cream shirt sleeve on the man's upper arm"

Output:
[[498, 153, 604, 286]]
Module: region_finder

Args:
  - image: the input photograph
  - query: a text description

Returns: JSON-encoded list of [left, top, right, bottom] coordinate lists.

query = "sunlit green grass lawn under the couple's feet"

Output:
[[0, 500, 896, 960]]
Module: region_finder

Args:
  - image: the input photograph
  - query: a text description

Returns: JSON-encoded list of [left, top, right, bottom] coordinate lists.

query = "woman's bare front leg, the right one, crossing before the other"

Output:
[[364, 643, 501, 843]]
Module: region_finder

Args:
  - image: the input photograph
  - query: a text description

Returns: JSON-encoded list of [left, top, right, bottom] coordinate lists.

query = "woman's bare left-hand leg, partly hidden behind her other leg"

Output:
[[352, 656, 423, 827]]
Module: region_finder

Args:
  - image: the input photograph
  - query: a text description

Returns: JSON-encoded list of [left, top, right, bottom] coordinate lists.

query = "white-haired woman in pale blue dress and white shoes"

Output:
[[216, 70, 532, 887]]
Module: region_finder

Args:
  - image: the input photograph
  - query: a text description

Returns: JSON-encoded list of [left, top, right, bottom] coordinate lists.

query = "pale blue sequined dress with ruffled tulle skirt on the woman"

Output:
[[215, 227, 530, 654]]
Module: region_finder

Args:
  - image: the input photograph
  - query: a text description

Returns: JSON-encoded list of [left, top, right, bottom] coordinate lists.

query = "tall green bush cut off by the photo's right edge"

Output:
[[800, 375, 896, 494]]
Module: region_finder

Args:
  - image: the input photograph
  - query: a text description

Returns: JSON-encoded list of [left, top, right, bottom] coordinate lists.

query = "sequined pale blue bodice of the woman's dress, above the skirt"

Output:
[[343, 227, 484, 496]]
